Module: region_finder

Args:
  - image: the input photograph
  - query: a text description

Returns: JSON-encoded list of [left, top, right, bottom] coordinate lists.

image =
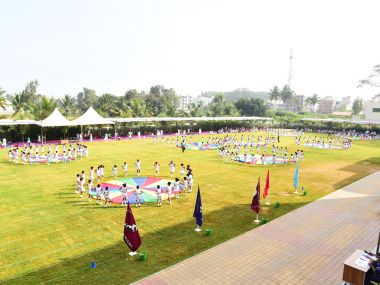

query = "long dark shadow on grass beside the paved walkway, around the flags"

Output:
[[0, 201, 306, 284]]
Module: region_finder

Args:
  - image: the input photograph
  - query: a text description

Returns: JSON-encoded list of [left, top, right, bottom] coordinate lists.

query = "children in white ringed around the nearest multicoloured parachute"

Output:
[[75, 159, 194, 207]]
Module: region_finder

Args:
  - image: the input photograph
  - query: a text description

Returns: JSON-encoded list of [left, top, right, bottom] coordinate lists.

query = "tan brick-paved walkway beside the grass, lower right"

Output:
[[137, 171, 380, 285]]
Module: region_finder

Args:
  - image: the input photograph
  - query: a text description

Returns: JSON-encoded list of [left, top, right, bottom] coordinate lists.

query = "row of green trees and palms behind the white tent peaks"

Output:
[[0, 80, 267, 120]]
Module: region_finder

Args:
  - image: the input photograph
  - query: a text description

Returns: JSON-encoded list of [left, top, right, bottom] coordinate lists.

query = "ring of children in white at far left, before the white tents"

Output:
[[8, 143, 88, 164]]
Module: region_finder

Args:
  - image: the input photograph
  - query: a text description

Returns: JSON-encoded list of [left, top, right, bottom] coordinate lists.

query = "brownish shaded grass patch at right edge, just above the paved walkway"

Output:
[[334, 157, 380, 189]]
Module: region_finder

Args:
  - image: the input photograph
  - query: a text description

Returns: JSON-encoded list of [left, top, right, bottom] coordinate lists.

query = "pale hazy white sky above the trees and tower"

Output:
[[0, 0, 380, 98]]
